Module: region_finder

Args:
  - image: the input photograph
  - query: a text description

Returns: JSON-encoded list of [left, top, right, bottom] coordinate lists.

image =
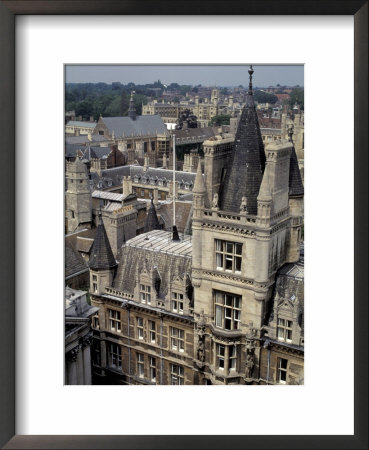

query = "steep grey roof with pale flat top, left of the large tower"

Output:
[[113, 230, 192, 298]]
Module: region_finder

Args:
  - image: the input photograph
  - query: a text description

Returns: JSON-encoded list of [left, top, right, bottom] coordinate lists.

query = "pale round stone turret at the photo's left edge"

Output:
[[65, 157, 92, 233]]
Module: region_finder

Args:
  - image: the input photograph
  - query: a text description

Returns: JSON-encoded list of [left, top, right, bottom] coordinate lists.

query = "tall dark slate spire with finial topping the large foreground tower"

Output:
[[219, 69, 265, 214]]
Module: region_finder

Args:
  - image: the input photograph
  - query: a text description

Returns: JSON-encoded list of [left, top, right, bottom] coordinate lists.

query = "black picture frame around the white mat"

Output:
[[0, 0, 368, 449]]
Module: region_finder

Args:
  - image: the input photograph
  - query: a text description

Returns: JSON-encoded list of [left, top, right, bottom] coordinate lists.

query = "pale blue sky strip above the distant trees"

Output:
[[65, 65, 304, 87]]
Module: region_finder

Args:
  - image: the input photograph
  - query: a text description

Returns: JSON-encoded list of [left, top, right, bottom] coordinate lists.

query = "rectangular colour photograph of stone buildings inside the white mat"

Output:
[[64, 64, 304, 385]]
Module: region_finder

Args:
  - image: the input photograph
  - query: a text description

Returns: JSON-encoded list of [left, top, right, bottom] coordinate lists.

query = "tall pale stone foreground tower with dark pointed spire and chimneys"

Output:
[[192, 66, 292, 384]]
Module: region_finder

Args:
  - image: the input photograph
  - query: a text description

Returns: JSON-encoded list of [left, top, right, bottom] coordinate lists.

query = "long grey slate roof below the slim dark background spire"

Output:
[[102, 115, 169, 138]]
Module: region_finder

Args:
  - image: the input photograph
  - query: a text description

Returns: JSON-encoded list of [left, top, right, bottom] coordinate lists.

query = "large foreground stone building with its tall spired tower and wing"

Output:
[[90, 69, 304, 384]]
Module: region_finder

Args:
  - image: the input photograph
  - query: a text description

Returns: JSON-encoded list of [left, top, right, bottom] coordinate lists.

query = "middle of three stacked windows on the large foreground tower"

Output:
[[214, 291, 241, 330]]
